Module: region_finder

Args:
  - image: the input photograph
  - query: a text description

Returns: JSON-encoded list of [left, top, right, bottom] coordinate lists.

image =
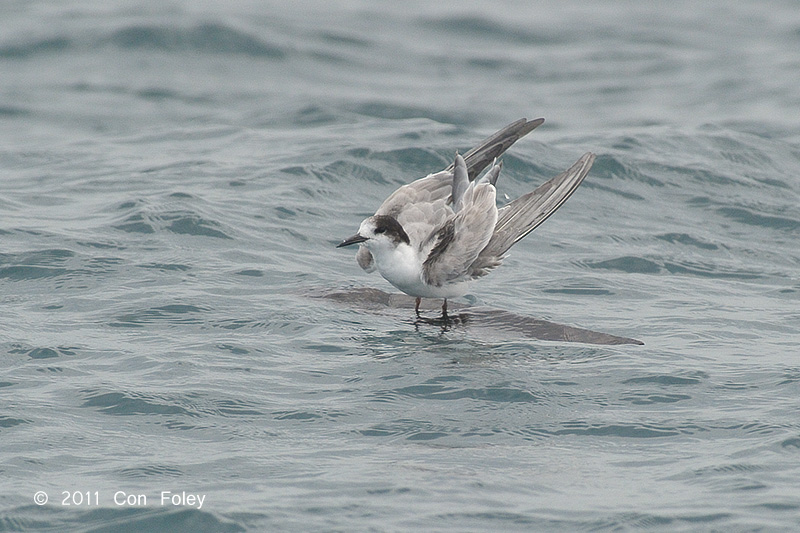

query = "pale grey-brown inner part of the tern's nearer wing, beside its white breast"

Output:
[[422, 182, 497, 287]]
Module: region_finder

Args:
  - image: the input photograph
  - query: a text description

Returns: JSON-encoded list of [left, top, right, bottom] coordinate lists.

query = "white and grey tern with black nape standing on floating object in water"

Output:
[[337, 118, 596, 320]]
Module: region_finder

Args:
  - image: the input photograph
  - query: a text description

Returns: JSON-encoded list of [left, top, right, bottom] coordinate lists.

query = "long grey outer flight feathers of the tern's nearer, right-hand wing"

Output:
[[470, 152, 595, 277]]
